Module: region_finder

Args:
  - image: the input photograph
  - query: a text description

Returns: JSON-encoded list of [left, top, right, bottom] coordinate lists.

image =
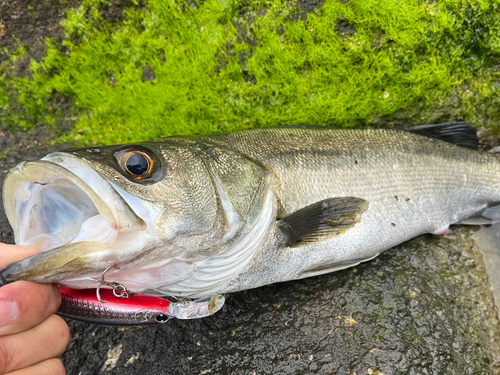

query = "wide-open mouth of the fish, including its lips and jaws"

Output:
[[3, 153, 147, 282]]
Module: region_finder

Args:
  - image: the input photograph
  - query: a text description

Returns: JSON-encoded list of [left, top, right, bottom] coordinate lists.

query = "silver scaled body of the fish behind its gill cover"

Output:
[[204, 128, 500, 291]]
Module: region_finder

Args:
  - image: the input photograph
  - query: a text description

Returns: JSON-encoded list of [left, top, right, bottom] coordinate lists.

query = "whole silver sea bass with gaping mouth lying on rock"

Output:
[[0, 123, 500, 298]]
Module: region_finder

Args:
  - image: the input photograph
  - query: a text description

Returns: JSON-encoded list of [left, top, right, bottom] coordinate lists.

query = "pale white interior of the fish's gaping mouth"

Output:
[[5, 154, 145, 251]]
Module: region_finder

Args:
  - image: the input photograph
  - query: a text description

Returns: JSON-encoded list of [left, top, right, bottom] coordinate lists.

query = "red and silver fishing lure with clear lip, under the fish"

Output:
[[58, 286, 224, 326]]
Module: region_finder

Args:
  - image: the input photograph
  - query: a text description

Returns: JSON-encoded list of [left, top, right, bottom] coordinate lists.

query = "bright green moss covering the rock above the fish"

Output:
[[0, 0, 500, 144]]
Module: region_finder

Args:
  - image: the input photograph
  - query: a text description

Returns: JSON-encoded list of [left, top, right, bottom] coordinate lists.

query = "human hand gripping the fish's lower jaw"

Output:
[[0, 243, 69, 375]]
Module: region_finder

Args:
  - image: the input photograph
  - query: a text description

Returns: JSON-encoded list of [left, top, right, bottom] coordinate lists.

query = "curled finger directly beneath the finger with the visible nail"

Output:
[[0, 315, 69, 374]]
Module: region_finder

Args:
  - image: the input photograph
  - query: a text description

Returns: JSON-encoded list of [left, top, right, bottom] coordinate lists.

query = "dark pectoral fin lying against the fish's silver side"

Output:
[[279, 197, 368, 247]]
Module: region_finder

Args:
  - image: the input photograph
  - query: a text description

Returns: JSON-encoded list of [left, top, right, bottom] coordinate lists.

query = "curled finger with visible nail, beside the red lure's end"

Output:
[[0, 281, 61, 336]]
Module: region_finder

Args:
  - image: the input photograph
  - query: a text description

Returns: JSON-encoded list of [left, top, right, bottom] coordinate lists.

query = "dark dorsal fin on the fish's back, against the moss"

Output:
[[406, 121, 479, 150]]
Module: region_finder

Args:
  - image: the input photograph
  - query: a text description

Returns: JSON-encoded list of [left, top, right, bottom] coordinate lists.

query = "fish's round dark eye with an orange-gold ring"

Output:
[[115, 146, 159, 181]]
